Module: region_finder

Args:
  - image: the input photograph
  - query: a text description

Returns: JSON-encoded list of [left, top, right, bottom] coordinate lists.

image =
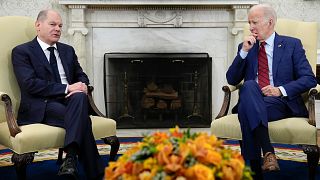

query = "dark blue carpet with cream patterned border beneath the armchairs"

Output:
[[0, 137, 320, 180]]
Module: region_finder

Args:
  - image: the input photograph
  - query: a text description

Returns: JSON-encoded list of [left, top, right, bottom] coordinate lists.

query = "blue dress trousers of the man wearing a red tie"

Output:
[[238, 80, 291, 160]]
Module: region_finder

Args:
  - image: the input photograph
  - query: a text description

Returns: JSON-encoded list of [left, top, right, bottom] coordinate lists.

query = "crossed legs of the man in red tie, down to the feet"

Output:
[[238, 80, 291, 179]]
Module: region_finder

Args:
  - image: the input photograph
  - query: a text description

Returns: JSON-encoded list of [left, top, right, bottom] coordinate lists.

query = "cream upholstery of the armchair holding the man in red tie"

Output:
[[211, 19, 319, 145]]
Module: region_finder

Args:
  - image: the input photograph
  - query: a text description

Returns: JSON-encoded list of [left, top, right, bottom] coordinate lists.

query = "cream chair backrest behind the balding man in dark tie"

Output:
[[0, 16, 36, 122]]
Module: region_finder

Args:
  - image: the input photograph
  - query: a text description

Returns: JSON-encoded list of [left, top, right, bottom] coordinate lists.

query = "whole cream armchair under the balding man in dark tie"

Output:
[[0, 16, 119, 179]]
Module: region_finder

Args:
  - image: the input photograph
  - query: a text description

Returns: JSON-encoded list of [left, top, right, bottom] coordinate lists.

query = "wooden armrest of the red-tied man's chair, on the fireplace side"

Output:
[[216, 83, 242, 119]]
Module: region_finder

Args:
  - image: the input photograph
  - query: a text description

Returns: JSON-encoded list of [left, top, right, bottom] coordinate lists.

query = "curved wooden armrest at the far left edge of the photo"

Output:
[[0, 92, 21, 137]]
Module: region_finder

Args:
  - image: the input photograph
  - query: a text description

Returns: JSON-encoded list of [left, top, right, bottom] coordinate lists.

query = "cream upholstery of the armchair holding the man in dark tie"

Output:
[[0, 16, 116, 154]]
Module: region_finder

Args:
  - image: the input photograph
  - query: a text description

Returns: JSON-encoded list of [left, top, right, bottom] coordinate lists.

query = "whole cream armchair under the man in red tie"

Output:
[[211, 19, 320, 179]]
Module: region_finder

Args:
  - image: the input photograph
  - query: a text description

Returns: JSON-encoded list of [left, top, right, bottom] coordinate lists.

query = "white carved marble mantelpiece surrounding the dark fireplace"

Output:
[[59, 0, 259, 117]]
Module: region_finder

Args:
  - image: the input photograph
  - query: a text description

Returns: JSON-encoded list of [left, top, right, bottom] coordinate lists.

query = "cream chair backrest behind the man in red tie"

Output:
[[243, 19, 318, 74]]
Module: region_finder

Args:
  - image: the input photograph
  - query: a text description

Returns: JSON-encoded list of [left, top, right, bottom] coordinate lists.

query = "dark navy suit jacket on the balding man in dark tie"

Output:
[[12, 38, 89, 125]]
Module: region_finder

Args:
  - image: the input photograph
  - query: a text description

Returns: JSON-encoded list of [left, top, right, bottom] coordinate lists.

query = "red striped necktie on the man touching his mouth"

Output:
[[258, 42, 270, 88]]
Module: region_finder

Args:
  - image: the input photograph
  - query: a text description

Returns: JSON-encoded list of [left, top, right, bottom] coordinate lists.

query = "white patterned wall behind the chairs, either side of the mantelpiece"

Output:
[[0, 0, 320, 49]]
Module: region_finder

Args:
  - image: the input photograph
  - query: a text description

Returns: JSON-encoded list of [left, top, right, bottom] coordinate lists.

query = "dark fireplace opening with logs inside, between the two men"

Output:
[[104, 53, 212, 128]]
